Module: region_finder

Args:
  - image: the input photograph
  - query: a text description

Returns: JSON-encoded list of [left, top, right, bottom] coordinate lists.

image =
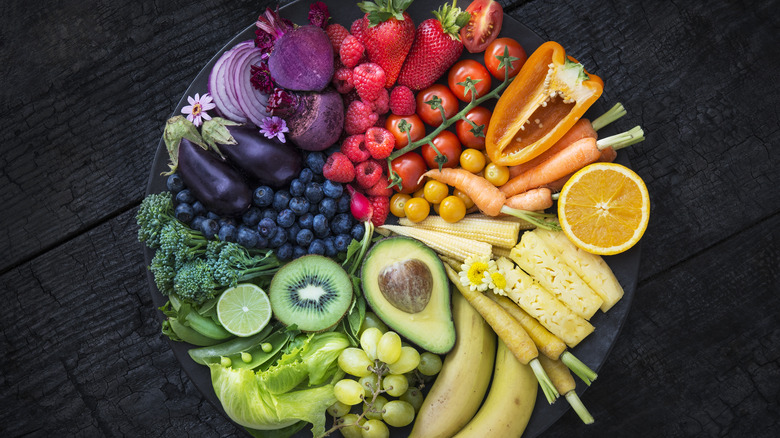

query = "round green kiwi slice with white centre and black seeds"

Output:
[[268, 255, 352, 332]]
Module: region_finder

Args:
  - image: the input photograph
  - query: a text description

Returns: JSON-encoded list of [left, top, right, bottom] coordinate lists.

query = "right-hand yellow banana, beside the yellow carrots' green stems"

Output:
[[453, 340, 539, 438]]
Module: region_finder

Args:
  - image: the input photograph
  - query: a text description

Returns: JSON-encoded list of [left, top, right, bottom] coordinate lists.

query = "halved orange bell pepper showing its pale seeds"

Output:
[[485, 41, 604, 166]]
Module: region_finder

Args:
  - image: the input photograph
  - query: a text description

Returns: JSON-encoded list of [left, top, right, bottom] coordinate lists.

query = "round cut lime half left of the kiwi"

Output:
[[217, 283, 272, 337]]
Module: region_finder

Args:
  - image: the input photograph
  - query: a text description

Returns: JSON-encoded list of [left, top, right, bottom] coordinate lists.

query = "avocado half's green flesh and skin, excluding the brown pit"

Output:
[[360, 236, 455, 354]]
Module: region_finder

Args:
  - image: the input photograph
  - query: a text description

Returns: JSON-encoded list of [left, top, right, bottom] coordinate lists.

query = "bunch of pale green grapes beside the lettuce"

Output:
[[328, 313, 442, 438]]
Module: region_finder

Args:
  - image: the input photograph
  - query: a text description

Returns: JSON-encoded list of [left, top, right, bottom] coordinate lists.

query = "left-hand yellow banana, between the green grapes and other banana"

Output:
[[409, 293, 496, 438]]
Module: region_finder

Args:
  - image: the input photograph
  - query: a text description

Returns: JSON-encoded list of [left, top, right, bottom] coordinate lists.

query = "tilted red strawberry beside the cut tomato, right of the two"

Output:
[[396, 2, 470, 91]]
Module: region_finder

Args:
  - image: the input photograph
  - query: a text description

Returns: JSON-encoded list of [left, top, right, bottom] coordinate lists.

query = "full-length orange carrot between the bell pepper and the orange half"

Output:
[[500, 126, 644, 196]]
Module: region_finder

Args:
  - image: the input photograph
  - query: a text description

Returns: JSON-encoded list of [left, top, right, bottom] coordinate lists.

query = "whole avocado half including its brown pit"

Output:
[[361, 236, 455, 354]]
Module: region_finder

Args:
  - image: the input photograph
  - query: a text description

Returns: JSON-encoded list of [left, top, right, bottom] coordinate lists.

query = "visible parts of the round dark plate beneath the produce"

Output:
[[144, 0, 641, 438]]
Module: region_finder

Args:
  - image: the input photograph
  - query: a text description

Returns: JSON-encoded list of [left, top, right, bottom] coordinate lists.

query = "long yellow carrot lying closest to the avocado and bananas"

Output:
[[444, 264, 559, 404]]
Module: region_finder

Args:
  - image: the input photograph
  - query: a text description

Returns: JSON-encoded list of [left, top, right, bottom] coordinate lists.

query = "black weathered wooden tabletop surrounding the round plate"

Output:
[[0, 0, 780, 437]]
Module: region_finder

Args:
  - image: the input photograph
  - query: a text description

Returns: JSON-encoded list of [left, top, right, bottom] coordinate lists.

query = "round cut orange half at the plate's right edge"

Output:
[[558, 163, 650, 255]]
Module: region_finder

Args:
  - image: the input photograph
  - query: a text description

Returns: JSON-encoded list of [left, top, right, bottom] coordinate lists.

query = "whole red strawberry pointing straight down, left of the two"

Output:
[[352, 0, 414, 87]]
